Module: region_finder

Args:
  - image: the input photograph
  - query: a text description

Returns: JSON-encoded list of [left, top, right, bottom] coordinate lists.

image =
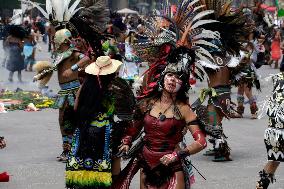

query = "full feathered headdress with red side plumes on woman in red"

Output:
[[131, 0, 220, 96]]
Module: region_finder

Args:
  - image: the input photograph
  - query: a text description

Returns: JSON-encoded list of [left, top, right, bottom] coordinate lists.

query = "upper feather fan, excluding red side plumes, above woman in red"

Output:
[[135, 0, 220, 64]]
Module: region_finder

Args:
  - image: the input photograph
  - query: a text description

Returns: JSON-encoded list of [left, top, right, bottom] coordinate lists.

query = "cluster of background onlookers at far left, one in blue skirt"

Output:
[[1, 13, 53, 82]]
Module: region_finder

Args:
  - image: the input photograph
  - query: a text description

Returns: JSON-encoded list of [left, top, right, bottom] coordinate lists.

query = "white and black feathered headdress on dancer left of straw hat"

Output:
[[22, 0, 109, 56]]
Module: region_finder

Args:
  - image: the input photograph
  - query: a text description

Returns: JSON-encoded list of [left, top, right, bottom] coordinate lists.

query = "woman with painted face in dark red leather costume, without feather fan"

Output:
[[112, 49, 206, 189]]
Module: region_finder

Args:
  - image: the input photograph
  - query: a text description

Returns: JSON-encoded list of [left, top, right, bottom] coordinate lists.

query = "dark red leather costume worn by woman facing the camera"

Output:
[[112, 101, 194, 189]]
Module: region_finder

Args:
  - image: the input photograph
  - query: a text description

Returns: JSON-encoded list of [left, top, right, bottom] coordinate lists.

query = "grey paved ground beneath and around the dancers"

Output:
[[0, 41, 284, 189]]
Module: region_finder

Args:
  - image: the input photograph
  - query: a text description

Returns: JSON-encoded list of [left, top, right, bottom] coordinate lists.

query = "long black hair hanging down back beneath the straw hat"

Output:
[[77, 73, 116, 127]]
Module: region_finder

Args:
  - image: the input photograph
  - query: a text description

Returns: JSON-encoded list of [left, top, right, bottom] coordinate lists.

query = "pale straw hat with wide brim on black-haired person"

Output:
[[85, 56, 122, 75]]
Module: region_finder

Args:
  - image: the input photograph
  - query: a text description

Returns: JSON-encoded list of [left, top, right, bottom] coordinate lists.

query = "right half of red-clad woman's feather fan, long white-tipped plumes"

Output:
[[173, 0, 220, 68]]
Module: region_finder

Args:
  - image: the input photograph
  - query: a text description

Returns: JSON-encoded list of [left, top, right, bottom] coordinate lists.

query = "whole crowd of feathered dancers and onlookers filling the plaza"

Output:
[[0, 0, 284, 189]]
